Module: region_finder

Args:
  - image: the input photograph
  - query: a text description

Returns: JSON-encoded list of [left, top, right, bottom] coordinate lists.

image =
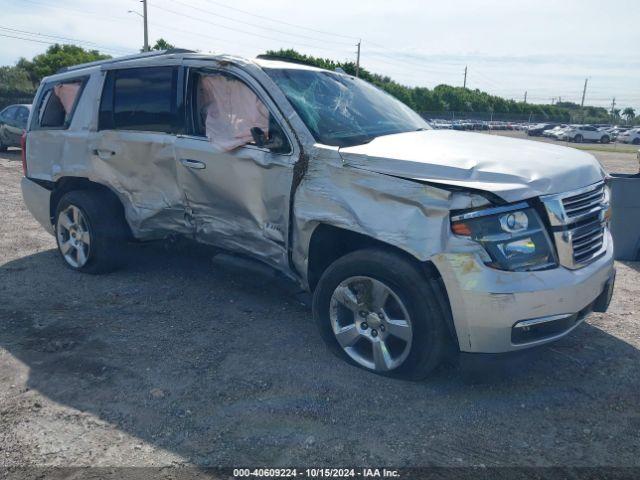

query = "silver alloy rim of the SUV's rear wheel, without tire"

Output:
[[56, 205, 91, 268]]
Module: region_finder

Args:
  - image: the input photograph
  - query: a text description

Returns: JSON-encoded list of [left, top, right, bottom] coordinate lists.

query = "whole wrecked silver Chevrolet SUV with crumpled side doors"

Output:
[[22, 50, 615, 378]]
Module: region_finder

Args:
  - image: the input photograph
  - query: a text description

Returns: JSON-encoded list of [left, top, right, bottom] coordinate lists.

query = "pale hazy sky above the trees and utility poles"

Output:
[[0, 0, 640, 113]]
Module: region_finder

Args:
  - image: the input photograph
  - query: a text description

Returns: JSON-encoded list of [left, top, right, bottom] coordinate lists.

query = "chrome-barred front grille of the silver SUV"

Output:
[[542, 182, 609, 269]]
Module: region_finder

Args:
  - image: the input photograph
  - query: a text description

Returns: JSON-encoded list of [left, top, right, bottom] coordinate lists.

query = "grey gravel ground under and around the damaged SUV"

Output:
[[0, 143, 640, 467]]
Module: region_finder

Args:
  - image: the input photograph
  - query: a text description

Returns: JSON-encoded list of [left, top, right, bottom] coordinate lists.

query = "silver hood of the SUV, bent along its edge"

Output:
[[340, 130, 605, 202]]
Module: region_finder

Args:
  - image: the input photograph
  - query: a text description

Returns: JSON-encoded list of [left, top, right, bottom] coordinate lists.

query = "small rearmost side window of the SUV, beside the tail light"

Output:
[[37, 78, 86, 129]]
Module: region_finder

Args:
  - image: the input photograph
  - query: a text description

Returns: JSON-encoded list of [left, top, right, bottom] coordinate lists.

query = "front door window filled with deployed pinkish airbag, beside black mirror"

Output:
[[190, 72, 291, 154]]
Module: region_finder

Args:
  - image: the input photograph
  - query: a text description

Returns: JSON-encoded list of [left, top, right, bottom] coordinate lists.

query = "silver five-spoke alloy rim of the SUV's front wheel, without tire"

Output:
[[329, 276, 413, 372]]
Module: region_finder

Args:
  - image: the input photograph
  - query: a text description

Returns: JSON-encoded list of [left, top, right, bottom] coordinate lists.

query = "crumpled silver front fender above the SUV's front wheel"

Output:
[[293, 145, 489, 282]]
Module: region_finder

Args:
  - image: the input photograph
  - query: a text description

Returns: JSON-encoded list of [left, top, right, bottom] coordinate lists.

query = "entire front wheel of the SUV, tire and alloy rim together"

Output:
[[313, 248, 448, 380]]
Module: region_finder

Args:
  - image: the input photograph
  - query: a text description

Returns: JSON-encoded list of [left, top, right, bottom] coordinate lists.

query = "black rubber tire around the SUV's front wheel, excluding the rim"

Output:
[[313, 249, 452, 380]]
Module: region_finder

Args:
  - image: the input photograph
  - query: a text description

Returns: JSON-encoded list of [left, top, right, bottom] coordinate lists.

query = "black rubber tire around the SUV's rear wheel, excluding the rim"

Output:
[[54, 190, 129, 274]]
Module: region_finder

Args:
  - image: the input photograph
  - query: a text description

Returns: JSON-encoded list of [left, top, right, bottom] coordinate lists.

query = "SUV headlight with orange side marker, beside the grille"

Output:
[[451, 203, 557, 271]]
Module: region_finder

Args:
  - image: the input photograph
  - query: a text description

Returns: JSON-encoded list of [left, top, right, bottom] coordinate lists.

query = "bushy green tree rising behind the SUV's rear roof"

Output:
[[16, 44, 111, 85]]
